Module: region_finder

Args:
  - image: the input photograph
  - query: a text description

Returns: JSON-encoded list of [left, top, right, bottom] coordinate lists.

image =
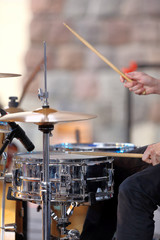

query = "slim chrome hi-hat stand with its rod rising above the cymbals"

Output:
[[38, 42, 54, 240]]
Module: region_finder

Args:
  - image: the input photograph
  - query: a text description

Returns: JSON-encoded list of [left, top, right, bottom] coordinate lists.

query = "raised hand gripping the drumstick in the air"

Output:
[[120, 72, 160, 95]]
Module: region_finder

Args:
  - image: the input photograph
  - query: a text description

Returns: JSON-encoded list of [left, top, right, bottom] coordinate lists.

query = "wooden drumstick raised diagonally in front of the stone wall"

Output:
[[63, 23, 132, 82]]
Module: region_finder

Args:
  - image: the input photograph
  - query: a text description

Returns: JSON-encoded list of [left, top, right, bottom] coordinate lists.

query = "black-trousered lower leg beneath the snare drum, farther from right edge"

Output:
[[80, 196, 117, 240]]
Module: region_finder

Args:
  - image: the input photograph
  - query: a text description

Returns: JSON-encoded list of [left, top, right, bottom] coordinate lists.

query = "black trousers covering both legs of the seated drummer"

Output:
[[81, 147, 160, 240]]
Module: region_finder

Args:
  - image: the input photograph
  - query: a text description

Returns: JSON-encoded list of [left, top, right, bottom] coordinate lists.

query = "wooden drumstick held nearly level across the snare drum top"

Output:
[[68, 151, 143, 158]]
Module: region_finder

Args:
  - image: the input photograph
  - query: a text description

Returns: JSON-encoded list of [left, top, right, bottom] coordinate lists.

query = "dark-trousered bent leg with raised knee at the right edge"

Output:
[[117, 164, 160, 240]]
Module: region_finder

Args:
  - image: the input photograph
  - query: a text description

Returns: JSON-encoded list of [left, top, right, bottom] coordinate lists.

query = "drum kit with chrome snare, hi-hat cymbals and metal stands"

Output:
[[0, 43, 134, 240]]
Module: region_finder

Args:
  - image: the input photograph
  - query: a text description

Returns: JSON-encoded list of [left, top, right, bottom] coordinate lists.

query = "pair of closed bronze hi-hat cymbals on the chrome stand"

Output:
[[0, 108, 96, 125]]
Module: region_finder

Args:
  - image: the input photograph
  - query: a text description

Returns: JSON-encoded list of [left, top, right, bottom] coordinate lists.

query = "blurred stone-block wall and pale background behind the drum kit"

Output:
[[0, 0, 160, 149]]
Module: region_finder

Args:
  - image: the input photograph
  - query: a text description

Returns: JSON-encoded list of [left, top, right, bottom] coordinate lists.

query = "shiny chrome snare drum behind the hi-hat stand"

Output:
[[12, 151, 113, 203]]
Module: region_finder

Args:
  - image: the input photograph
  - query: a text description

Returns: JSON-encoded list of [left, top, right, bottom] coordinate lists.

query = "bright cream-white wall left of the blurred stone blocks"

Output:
[[0, 0, 31, 106]]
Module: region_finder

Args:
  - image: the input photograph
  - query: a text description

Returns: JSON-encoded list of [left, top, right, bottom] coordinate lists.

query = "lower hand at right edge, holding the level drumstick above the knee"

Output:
[[142, 143, 160, 166]]
